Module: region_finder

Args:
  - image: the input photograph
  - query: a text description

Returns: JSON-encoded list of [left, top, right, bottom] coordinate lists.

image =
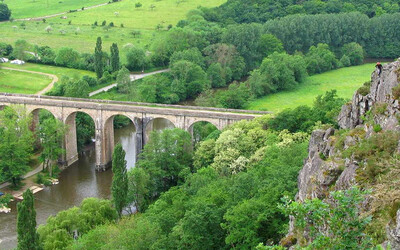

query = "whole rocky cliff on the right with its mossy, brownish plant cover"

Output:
[[289, 61, 400, 249]]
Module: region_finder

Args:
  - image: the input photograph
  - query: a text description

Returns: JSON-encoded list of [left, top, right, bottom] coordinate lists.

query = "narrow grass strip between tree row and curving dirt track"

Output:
[[3, 63, 95, 79]]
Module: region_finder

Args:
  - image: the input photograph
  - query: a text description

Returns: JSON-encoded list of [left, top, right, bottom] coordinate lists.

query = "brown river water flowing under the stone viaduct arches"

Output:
[[0, 119, 171, 249]]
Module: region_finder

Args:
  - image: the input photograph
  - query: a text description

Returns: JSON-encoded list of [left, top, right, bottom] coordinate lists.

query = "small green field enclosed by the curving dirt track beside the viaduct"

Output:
[[0, 69, 52, 94]]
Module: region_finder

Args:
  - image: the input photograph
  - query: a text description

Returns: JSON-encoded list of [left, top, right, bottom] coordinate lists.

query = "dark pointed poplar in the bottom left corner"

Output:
[[17, 188, 41, 250]]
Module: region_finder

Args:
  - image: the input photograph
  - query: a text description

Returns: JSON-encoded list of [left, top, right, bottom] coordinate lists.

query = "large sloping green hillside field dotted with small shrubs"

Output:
[[0, 0, 226, 53]]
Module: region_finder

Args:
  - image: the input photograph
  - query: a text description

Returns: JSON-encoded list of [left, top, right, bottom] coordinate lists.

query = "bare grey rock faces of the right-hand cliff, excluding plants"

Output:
[[289, 61, 400, 249]]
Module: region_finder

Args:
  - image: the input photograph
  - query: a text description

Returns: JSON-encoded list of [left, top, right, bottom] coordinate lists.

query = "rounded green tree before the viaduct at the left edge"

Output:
[[0, 106, 33, 187]]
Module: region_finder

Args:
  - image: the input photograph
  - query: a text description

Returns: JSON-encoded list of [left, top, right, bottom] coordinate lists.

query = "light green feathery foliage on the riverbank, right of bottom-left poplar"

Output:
[[38, 198, 117, 250]]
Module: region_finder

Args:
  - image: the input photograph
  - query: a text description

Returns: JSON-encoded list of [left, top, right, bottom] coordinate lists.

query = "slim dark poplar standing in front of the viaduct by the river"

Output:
[[111, 143, 128, 217]]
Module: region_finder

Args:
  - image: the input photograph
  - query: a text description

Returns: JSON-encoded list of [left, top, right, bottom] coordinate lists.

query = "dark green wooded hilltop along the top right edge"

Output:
[[203, 0, 400, 24]]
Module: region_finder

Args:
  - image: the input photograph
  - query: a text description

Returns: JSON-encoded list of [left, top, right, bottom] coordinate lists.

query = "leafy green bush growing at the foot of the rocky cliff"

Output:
[[281, 187, 372, 249]]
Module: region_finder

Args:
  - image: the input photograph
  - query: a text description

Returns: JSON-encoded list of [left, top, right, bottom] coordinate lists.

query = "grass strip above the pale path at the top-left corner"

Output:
[[4, 0, 108, 19]]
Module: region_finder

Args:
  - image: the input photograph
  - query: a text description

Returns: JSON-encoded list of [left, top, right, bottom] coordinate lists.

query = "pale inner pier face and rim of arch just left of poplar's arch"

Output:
[[64, 110, 98, 166]]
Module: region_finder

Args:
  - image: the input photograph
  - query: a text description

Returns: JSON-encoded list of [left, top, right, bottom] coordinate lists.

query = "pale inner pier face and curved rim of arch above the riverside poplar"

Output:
[[102, 113, 137, 168]]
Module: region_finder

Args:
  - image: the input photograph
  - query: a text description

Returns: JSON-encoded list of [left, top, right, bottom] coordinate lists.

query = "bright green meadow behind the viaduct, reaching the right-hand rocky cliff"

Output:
[[246, 63, 375, 112]]
